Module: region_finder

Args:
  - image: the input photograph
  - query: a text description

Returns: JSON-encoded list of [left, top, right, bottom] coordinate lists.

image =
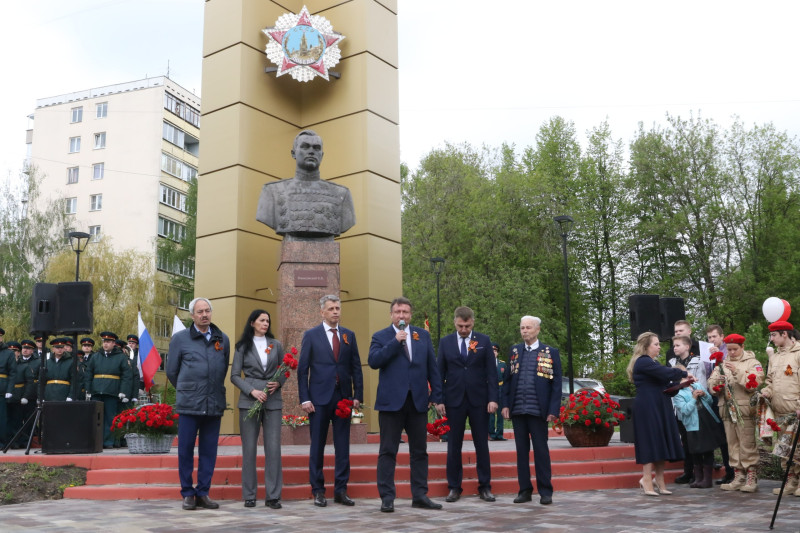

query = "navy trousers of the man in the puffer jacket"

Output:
[[178, 415, 222, 498]]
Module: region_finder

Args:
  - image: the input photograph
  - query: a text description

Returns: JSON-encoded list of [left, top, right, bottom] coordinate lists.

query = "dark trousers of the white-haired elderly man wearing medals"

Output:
[[511, 415, 553, 497]]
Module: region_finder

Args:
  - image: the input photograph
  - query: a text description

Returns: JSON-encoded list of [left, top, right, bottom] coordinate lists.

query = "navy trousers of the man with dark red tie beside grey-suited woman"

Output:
[[308, 387, 350, 494]]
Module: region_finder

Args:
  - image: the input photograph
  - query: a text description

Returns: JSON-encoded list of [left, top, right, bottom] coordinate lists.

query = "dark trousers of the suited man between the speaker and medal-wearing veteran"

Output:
[[447, 398, 492, 490]]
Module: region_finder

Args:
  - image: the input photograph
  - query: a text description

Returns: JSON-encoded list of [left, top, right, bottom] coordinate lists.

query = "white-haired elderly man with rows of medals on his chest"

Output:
[[502, 316, 561, 505]]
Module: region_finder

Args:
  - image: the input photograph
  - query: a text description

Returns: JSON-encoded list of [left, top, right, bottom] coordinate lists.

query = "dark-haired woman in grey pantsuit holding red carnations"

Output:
[[231, 309, 286, 509]]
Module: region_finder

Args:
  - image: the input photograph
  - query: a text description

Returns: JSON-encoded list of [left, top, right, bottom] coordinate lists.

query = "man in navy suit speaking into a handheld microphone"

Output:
[[367, 297, 442, 513]]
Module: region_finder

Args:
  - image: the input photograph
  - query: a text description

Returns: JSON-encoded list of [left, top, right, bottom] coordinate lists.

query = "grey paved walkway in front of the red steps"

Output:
[[0, 481, 800, 533]]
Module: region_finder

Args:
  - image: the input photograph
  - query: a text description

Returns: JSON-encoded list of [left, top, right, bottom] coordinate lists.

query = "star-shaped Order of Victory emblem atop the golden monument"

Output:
[[261, 6, 344, 81]]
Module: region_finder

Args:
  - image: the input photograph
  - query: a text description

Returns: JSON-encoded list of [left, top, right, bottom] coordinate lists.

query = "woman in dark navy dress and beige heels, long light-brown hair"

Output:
[[628, 331, 687, 496]]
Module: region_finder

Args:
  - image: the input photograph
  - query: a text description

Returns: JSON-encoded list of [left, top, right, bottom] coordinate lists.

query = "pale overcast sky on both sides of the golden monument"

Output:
[[0, 0, 800, 181]]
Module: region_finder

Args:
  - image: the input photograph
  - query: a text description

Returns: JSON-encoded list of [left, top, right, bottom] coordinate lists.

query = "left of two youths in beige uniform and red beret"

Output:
[[708, 333, 764, 492]]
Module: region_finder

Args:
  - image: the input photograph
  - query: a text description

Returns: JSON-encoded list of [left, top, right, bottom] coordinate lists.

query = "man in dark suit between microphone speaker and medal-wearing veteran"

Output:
[[436, 307, 499, 502]]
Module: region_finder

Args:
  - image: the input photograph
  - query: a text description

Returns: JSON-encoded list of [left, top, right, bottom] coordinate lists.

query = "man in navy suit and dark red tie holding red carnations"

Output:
[[297, 294, 364, 507]]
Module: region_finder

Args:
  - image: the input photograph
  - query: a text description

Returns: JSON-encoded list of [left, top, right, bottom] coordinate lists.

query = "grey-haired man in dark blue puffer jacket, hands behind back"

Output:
[[167, 298, 231, 511]]
